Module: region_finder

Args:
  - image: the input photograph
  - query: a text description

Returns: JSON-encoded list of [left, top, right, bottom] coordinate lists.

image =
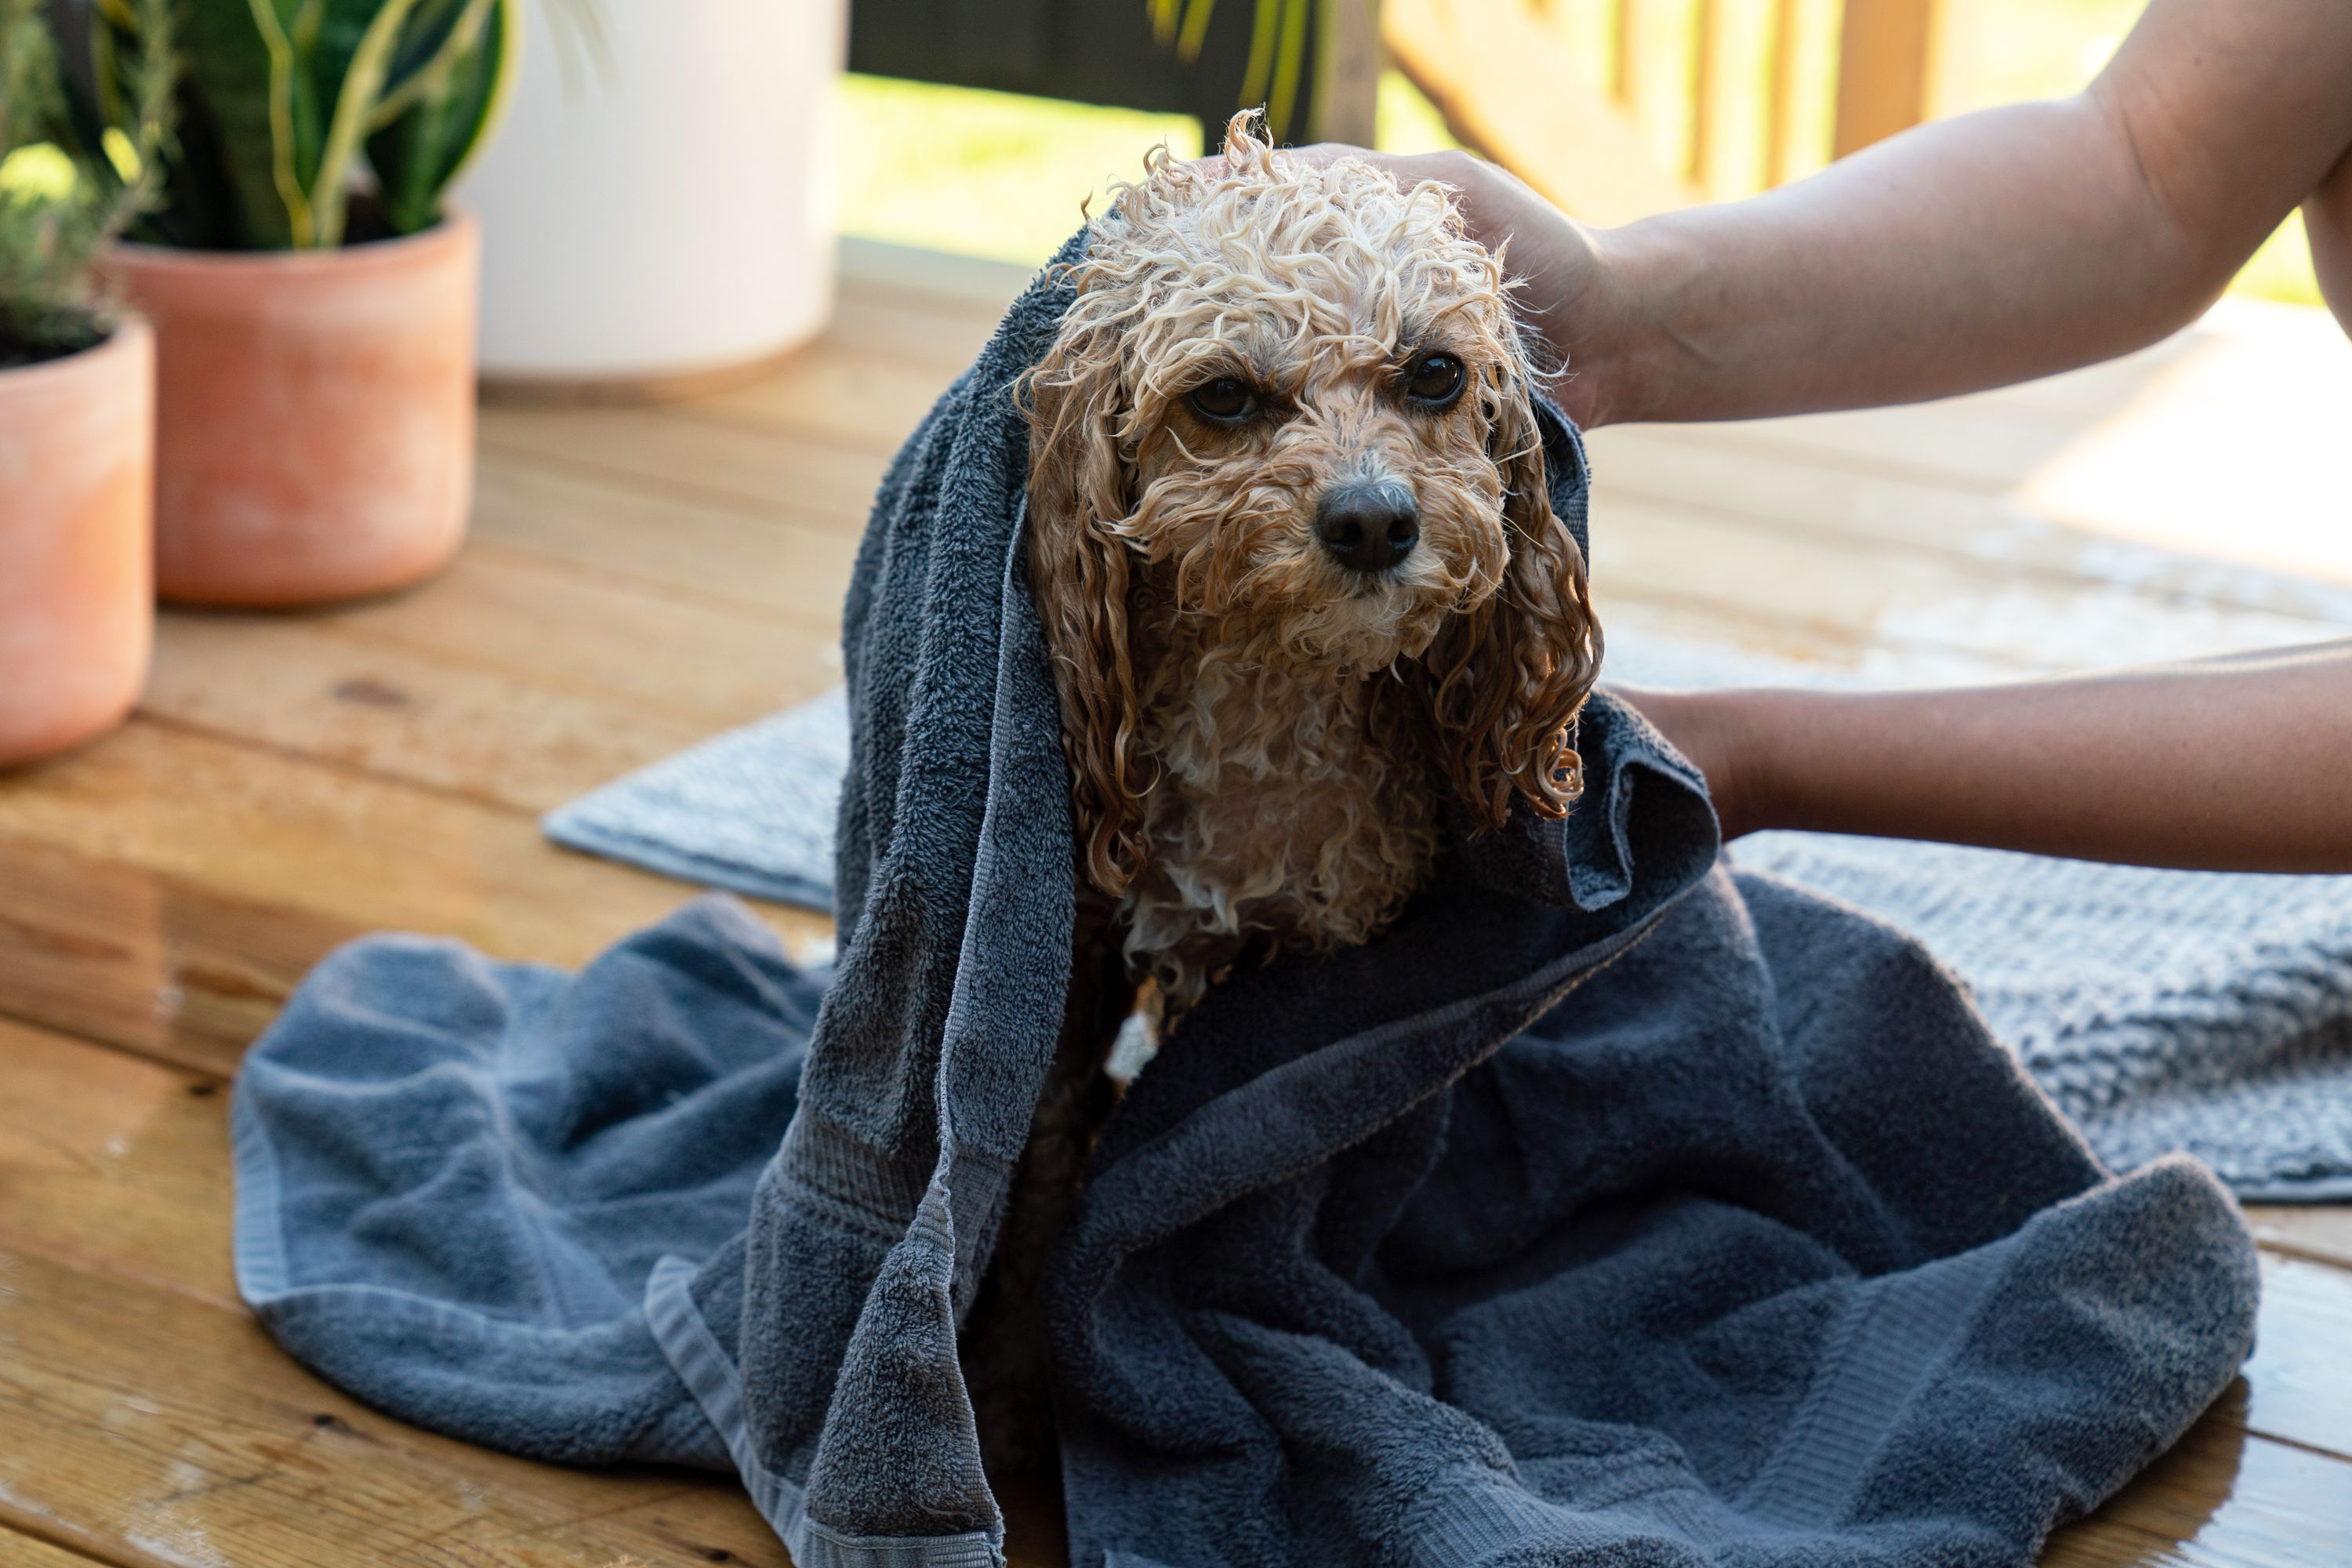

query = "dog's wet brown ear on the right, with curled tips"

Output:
[[1423, 367, 1602, 827]]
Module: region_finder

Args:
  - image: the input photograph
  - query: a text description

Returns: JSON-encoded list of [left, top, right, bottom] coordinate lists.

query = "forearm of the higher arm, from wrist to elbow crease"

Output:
[[1559, 99, 2220, 423]]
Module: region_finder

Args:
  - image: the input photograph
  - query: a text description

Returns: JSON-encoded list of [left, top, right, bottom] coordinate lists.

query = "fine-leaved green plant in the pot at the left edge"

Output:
[[0, 0, 176, 367]]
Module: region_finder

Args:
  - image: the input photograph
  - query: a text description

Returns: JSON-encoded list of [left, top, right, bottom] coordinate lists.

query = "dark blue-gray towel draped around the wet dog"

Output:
[[235, 239, 2256, 1568]]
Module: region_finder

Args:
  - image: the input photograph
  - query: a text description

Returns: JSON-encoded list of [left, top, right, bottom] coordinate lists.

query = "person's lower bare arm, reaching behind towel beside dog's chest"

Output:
[[1618, 640, 2352, 872]]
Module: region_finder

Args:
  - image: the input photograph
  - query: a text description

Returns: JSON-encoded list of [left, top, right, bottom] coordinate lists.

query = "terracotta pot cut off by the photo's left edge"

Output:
[[0, 320, 155, 767]]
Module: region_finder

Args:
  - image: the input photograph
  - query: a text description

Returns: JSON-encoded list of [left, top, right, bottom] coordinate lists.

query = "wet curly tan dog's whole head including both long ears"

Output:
[[1023, 118, 1599, 891]]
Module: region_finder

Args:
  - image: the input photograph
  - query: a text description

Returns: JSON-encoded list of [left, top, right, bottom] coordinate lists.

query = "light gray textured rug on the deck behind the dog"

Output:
[[546, 633, 2352, 1201]]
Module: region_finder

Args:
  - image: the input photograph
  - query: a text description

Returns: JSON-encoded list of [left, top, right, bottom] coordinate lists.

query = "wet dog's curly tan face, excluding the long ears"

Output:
[[1103, 225, 1512, 673]]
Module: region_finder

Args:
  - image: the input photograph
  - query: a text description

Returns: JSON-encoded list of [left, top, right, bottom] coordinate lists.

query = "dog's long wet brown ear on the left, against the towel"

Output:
[[1021, 332, 1145, 898]]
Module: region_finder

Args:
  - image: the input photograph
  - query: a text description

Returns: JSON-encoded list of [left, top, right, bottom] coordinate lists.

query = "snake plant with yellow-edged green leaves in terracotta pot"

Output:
[[52, 0, 522, 249]]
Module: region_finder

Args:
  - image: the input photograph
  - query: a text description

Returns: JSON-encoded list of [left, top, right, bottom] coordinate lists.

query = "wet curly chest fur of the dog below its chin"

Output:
[[1120, 619, 1437, 1011]]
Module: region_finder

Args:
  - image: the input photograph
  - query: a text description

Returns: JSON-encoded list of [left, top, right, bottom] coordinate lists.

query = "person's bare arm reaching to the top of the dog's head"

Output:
[[1336, 0, 2352, 426]]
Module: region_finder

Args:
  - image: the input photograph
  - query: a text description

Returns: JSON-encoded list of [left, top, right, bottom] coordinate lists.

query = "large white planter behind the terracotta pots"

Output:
[[456, 0, 847, 393]]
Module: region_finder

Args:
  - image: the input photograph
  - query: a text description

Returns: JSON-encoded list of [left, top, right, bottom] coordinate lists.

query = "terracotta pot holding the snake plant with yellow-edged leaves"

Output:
[[113, 214, 482, 607]]
